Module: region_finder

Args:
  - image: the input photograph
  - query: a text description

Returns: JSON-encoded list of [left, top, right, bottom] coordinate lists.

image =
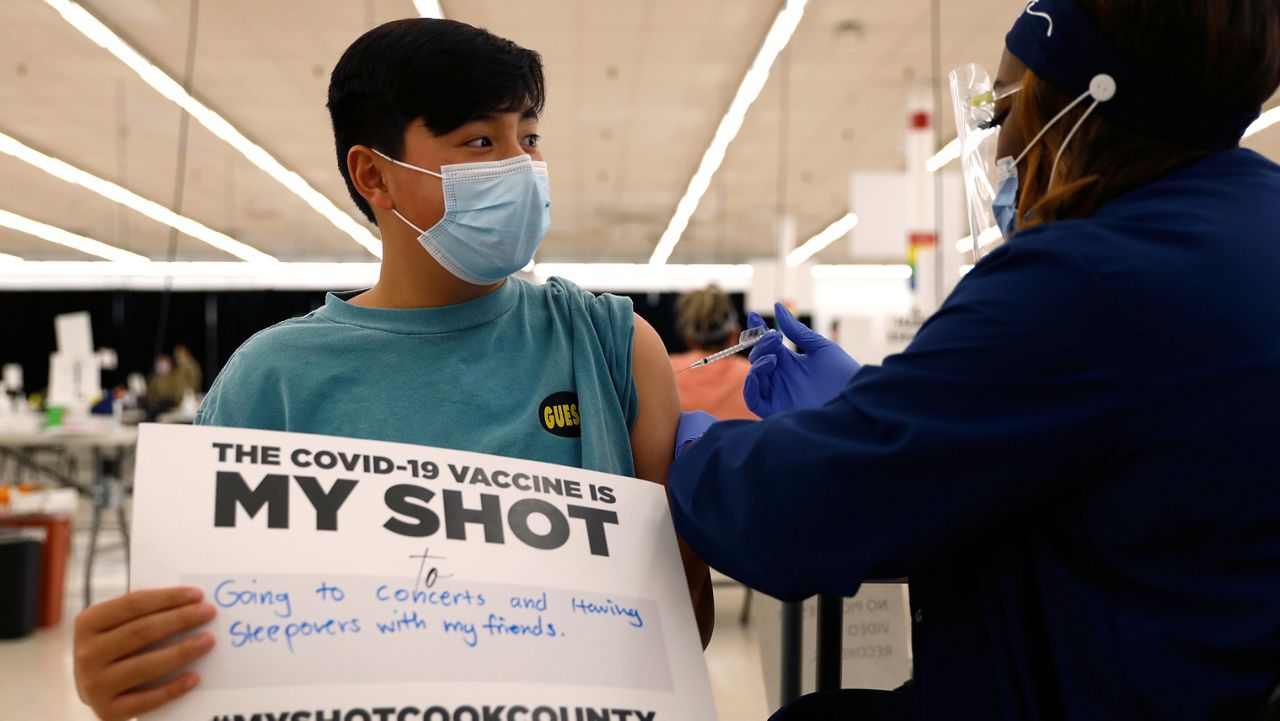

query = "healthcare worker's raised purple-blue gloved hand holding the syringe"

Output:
[[742, 304, 861, 417]]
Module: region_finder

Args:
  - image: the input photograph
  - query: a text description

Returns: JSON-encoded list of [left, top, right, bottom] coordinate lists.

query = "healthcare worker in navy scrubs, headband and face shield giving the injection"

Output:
[[669, 0, 1280, 721]]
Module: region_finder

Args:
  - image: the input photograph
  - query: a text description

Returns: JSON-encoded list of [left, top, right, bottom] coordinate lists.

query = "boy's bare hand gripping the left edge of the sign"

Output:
[[74, 588, 216, 721]]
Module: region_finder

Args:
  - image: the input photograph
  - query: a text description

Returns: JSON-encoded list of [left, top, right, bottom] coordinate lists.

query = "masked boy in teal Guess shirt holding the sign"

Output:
[[76, 19, 713, 720]]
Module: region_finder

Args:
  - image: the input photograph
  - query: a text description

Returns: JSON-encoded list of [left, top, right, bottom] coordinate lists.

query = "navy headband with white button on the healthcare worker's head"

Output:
[[1005, 0, 1262, 150]]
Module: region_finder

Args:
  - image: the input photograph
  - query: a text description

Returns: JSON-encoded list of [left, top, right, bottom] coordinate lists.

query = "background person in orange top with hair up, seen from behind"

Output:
[[671, 284, 756, 420]]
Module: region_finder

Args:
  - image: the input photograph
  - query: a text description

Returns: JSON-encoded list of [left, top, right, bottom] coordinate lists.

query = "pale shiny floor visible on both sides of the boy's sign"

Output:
[[0, 502, 768, 721]]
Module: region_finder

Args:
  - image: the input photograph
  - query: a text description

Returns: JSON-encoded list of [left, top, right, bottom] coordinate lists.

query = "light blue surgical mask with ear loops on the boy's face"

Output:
[[374, 150, 552, 286]]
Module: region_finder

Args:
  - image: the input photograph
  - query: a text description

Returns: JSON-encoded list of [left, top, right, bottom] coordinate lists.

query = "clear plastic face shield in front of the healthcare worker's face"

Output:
[[950, 64, 1020, 263]]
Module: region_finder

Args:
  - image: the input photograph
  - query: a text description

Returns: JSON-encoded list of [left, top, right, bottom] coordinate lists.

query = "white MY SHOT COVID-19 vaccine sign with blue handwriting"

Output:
[[132, 425, 714, 721]]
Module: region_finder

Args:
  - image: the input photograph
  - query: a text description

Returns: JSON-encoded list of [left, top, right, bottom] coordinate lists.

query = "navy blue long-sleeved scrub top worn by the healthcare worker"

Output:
[[669, 149, 1280, 721]]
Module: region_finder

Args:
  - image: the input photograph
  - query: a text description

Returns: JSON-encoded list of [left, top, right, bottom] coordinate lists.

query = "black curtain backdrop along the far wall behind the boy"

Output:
[[0, 291, 746, 393]]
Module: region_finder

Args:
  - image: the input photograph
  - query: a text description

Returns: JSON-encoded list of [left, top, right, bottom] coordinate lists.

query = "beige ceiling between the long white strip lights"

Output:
[[0, 0, 1280, 263]]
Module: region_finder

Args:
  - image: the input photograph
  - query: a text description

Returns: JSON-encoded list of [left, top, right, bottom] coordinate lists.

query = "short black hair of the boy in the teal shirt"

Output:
[[328, 18, 545, 222]]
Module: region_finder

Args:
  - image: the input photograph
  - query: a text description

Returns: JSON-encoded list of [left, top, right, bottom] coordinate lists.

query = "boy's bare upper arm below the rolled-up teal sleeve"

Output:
[[631, 315, 680, 484]]
